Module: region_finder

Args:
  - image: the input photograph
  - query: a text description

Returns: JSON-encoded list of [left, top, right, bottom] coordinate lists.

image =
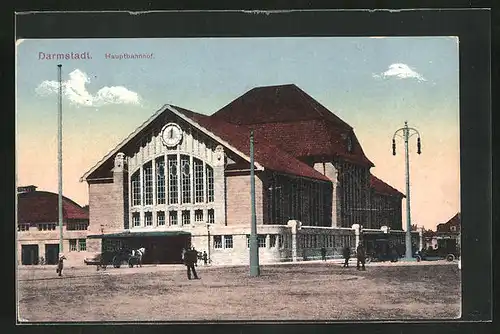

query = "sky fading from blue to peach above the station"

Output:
[[16, 36, 460, 229]]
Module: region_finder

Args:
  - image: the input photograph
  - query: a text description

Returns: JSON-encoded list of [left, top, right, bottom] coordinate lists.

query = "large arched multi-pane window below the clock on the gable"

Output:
[[130, 152, 215, 227]]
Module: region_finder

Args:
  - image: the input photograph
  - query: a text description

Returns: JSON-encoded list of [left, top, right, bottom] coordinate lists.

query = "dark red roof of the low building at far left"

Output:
[[17, 191, 89, 224]]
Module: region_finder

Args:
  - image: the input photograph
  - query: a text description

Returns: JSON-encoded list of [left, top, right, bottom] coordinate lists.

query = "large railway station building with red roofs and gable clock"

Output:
[[80, 85, 418, 264]]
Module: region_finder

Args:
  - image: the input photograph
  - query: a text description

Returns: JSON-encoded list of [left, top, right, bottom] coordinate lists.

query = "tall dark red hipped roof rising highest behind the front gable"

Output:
[[212, 85, 374, 167]]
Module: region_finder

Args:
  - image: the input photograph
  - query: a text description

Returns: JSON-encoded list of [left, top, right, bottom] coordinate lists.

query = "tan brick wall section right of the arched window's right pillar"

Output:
[[226, 175, 264, 226]]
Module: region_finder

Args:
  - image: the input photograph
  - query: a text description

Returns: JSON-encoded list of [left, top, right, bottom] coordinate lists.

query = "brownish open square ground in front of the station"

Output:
[[17, 261, 461, 322]]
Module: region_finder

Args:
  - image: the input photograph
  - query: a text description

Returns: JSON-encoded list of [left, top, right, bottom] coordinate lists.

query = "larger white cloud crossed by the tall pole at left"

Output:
[[36, 69, 140, 107]]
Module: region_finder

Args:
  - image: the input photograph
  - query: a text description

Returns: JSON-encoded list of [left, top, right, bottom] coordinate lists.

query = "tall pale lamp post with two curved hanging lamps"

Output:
[[392, 121, 421, 260]]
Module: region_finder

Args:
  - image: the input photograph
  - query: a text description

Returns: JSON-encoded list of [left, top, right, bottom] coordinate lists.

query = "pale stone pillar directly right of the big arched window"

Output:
[[213, 145, 226, 225]]
